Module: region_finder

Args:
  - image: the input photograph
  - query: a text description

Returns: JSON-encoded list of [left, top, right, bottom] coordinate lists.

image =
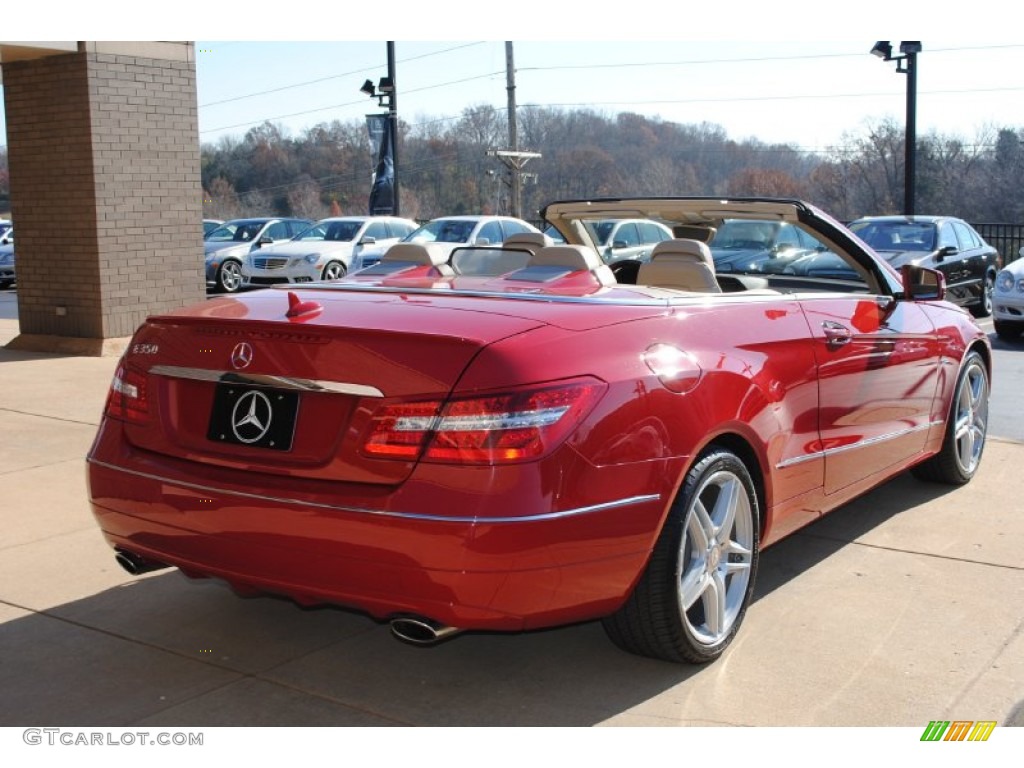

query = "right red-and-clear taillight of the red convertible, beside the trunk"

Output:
[[362, 379, 605, 464]]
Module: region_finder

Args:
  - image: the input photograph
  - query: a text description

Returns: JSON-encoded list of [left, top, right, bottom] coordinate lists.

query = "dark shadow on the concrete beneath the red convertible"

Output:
[[0, 468, 947, 726]]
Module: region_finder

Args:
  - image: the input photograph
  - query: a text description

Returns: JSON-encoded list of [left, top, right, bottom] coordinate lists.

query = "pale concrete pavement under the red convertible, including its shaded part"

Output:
[[0, 293, 1024, 729]]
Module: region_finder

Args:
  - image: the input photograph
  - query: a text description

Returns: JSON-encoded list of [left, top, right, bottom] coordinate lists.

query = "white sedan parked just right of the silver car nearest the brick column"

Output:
[[242, 216, 417, 286]]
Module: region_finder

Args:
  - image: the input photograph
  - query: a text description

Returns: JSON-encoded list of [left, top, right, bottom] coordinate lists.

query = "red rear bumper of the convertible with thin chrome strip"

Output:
[[88, 430, 666, 631]]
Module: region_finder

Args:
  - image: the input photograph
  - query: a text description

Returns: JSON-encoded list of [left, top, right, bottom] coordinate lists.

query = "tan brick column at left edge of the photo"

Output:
[[3, 43, 206, 354]]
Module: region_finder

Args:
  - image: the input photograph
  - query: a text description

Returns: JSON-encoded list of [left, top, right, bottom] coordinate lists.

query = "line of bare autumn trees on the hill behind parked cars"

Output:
[[192, 106, 1024, 228]]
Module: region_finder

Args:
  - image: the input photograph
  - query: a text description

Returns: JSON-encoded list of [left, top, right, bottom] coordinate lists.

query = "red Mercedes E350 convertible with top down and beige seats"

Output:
[[88, 198, 991, 663]]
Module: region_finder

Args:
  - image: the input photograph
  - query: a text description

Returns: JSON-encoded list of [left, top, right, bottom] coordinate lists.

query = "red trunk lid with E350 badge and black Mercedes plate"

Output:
[[124, 291, 557, 483]]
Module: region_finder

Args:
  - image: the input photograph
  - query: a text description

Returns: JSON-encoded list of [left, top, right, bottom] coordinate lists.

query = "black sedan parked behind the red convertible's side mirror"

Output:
[[850, 216, 1001, 317]]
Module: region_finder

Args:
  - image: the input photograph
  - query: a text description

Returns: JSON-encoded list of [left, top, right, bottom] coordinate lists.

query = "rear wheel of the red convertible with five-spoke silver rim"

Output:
[[603, 446, 760, 664]]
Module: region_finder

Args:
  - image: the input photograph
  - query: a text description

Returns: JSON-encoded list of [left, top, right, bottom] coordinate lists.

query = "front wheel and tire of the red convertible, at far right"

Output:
[[910, 351, 989, 485]]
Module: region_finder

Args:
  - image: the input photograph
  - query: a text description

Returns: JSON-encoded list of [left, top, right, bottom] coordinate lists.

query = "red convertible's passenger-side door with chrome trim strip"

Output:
[[802, 294, 939, 494]]
